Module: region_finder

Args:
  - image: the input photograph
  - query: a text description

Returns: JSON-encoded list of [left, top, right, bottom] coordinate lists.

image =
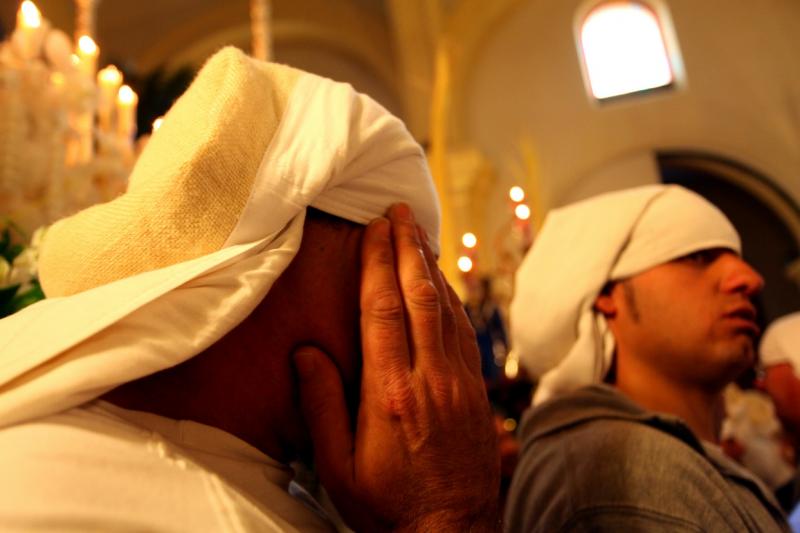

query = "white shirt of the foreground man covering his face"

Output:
[[0, 401, 334, 532]]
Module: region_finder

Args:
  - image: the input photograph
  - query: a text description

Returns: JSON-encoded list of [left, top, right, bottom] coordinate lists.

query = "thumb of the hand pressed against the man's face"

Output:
[[294, 346, 353, 493]]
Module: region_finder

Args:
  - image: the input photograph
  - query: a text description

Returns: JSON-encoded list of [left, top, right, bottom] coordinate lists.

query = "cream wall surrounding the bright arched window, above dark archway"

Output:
[[462, 0, 800, 217]]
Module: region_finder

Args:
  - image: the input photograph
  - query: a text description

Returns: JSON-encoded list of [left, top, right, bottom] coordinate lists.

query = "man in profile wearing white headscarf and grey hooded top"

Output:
[[506, 185, 787, 532]]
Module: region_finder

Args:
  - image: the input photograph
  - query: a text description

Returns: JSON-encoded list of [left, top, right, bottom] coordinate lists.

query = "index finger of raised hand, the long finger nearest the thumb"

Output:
[[361, 218, 411, 388]]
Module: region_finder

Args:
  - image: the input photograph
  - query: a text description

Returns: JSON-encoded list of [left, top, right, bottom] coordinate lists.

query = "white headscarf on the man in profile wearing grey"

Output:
[[511, 185, 741, 403]]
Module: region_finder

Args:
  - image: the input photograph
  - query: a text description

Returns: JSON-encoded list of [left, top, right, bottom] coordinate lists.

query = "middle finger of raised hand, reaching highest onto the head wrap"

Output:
[[389, 204, 443, 367]]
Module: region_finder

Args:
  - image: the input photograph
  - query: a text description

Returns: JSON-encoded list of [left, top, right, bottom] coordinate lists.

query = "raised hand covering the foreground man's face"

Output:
[[295, 204, 500, 531]]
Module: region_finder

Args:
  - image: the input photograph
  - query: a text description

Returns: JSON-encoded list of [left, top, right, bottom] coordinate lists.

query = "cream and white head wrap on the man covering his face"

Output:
[[0, 48, 439, 427]]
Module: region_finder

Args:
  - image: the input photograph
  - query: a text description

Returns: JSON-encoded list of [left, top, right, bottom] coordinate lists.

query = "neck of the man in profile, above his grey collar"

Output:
[[615, 362, 724, 444]]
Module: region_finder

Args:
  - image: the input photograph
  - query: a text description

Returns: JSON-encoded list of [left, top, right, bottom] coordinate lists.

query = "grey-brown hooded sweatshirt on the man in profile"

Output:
[[505, 385, 789, 533]]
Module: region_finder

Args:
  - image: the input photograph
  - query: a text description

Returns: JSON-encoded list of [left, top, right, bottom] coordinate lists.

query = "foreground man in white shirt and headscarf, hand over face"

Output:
[[0, 48, 497, 532]]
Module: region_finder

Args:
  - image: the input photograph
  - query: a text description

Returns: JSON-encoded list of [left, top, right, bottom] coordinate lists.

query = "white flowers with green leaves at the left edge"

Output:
[[0, 222, 46, 318]]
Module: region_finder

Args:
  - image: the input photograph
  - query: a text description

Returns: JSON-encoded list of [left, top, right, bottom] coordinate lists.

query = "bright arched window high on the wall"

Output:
[[579, 0, 675, 100]]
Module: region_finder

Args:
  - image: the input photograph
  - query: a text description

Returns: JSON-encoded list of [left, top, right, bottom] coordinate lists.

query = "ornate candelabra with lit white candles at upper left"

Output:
[[0, 0, 136, 233]]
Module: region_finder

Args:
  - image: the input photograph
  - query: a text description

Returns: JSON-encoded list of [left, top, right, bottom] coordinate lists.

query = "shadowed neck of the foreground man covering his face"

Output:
[[103, 312, 305, 463]]
